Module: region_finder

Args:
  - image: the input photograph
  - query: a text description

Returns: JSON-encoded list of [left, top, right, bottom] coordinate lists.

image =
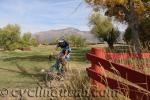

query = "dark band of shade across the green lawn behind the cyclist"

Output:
[[3, 48, 89, 62]]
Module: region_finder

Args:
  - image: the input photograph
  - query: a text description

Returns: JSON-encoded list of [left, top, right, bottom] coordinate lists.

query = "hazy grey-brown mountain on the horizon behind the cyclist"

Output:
[[34, 27, 99, 43]]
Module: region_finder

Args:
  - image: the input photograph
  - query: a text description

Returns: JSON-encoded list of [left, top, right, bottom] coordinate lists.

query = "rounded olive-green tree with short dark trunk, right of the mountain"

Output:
[[90, 13, 119, 49]]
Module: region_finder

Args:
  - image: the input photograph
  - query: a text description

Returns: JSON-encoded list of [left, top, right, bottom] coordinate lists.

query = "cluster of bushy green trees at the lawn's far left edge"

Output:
[[0, 24, 38, 50]]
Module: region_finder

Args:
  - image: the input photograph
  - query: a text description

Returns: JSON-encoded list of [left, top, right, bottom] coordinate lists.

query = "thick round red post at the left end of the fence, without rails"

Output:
[[90, 48, 106, 91]]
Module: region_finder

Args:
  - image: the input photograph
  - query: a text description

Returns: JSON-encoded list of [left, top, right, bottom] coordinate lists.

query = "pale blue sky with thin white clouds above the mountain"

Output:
[[0, 0, 126, 33]]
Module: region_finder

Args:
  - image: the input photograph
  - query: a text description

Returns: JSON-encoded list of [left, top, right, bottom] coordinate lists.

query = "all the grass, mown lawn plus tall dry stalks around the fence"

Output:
[[0, 44, 149, 100]]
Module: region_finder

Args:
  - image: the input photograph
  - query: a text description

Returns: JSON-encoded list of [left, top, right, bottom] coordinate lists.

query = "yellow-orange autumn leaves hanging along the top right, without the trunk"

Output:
[[87, 0, 150, 20]]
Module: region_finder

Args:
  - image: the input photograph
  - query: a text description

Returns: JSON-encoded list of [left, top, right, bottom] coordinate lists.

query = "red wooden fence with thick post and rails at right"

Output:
[[87, 48, 150, 100]]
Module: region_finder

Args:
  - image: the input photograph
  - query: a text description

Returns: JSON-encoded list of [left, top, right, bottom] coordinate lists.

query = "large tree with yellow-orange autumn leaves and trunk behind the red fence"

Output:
[[85, 0, 150, 53]]
